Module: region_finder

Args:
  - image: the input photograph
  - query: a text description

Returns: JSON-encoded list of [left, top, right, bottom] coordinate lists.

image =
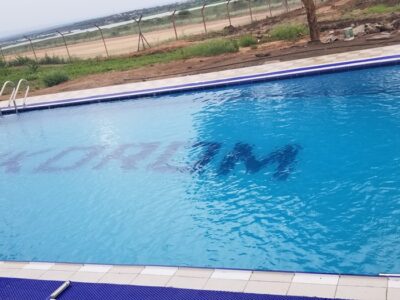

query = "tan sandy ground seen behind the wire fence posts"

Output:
[[6, 6, 302, 59]]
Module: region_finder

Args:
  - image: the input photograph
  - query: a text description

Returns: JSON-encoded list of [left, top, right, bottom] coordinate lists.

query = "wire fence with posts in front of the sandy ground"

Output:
[[0, 0, 330, 61]]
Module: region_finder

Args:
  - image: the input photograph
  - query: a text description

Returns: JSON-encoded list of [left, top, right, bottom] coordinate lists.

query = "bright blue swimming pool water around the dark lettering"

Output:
[[0, 66, 400, 274]]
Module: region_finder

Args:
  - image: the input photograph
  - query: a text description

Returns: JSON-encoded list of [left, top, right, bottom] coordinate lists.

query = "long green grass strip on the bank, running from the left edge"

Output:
[[0, 39, 239, 89]]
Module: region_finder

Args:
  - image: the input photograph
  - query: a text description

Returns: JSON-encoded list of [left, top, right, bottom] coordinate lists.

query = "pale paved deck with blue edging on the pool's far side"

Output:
[[0, 45, 400, 110]]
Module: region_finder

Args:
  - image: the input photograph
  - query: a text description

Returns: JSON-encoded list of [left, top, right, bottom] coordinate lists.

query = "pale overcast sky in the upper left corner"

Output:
[[0, 0, 180, 38]]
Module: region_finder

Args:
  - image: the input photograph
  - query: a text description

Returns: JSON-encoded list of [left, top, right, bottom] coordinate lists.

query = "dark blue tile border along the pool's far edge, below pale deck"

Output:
[[2, 55, 400, 115]]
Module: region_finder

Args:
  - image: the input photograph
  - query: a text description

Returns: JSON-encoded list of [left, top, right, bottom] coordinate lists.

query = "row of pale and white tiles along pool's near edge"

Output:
[[0, 262, 400, 300]]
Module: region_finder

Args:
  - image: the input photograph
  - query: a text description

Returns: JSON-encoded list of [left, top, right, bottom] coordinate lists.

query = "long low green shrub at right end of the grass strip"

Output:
[[182, 39, 239, 58]]
